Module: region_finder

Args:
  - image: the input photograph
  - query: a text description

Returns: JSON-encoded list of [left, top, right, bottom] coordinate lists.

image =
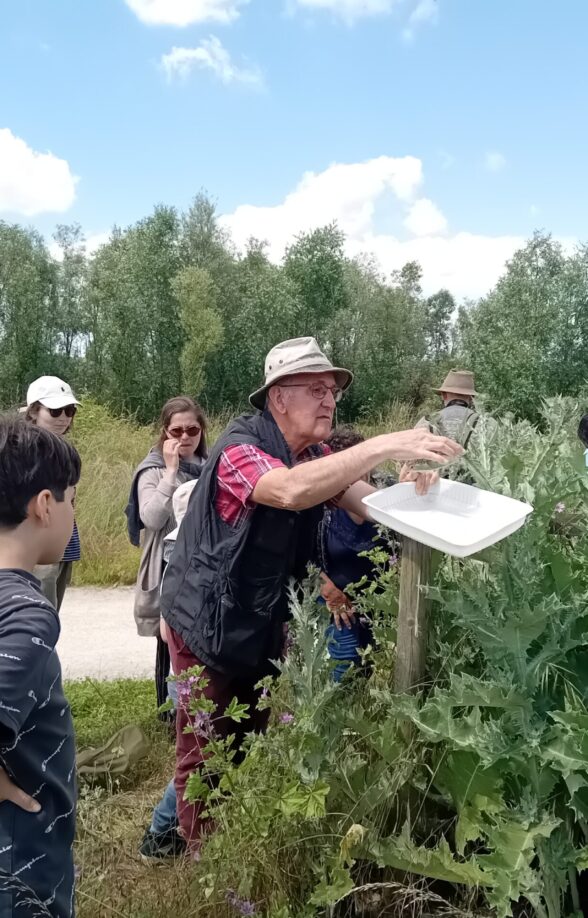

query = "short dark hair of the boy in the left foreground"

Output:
[[0, 415, 81, 529]]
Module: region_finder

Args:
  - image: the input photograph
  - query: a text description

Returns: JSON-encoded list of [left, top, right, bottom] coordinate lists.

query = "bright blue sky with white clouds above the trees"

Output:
[[0, 0, 588, 296]]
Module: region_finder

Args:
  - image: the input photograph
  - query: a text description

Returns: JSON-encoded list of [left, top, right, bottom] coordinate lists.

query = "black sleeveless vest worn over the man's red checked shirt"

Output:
[[161, 412, 324, 678]]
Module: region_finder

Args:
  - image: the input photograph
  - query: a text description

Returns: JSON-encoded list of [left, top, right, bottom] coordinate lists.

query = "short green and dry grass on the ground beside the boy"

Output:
[[65, 679, 199, 918]]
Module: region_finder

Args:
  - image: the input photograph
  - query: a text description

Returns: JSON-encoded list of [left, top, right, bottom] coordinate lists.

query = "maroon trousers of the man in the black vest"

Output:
[[167, 626, 269, 850]]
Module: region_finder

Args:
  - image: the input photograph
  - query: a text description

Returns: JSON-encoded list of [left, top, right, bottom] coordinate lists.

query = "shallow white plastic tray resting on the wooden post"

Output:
[[363, 486, 533, 558]]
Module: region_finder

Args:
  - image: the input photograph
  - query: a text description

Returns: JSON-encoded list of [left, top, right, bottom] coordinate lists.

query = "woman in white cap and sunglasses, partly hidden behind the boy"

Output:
[[21, 376, 80, 612]]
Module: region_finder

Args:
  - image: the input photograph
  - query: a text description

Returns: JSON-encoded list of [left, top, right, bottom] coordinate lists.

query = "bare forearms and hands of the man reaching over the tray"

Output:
[[252, 428, 463, 517]]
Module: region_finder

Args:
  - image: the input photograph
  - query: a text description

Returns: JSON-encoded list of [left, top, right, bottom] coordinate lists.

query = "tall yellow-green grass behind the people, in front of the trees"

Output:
[[73, 399, 422, 586]]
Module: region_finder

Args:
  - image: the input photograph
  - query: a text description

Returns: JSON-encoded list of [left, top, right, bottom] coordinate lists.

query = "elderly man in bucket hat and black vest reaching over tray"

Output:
[[162, 338, 461, 850]]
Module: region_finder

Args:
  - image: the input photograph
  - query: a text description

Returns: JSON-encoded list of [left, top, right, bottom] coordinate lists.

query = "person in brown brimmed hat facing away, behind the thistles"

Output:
[[417, 370, 480, 449]]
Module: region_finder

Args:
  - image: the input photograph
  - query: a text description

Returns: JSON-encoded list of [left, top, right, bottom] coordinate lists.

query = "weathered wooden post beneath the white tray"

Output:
[[394, 538, 431, 692]]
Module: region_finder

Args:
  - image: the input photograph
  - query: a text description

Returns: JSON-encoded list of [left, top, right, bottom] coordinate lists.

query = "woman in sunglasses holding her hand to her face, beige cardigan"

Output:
[[125, 395, 207, 719]]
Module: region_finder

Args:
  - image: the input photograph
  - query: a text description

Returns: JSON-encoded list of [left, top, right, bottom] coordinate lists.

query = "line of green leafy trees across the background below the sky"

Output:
[[0, 194, 588, 422]]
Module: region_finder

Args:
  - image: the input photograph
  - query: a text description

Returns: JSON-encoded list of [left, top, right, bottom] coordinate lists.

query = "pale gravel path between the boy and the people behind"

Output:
[[57, 587, 155, 679]]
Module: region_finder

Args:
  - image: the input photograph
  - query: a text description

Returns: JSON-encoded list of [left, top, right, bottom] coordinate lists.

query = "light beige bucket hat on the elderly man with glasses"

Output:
[[249, 338, 353, 410]]
